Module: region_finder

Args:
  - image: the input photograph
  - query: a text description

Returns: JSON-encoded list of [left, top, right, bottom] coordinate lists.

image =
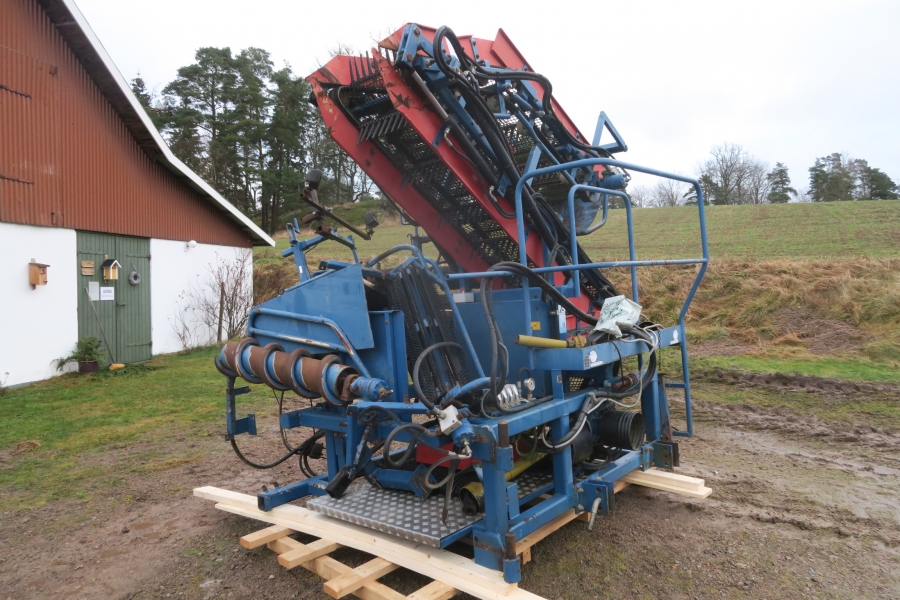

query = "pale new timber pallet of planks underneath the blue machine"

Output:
[[194, 469, 712, 600]]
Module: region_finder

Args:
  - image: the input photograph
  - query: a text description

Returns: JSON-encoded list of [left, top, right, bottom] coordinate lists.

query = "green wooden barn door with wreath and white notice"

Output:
[[76, 231, 152, 364]]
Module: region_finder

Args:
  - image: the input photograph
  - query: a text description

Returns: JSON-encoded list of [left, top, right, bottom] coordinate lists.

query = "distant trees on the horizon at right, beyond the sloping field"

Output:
[[628, 143, 900, 207]]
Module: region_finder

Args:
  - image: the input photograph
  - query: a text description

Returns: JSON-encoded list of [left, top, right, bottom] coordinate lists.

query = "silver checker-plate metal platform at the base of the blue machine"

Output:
[[306, 471, 553, 548]]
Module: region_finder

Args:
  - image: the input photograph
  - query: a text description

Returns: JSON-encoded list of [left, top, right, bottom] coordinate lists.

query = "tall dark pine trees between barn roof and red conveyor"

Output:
[[131, 47, 376, 233]]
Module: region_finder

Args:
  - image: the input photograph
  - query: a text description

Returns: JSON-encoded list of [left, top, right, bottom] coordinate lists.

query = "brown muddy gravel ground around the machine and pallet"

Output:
[[0, 384, 900, 600]]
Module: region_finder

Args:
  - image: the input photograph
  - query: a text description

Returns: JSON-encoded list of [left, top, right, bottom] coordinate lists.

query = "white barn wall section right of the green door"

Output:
[[150, 238, 252, 354]]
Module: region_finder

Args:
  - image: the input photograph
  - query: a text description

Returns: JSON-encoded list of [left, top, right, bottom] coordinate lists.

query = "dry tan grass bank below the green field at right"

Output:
[[608, 258, 900, 344]]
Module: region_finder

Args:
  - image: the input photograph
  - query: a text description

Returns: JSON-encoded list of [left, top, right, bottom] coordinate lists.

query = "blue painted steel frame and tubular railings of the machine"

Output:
[[227, 164, 709, 582]]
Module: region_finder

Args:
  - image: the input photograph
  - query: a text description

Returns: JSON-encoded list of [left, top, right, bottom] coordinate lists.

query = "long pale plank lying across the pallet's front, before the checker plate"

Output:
[[194, 487, 540, 600]]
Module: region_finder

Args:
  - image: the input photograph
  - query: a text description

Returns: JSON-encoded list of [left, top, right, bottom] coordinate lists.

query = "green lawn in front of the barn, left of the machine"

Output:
[[0, 349, 272, 511]]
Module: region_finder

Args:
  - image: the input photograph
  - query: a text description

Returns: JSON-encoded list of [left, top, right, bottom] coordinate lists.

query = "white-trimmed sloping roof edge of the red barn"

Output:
[[38, 0, 275, 246]]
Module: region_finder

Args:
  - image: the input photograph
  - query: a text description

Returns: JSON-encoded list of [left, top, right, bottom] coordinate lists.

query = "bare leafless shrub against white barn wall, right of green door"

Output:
[[169, 249, 253, 348]]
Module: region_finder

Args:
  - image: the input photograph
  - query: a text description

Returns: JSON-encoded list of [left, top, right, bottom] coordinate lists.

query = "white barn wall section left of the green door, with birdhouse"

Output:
[[0, 223, 78, 386]]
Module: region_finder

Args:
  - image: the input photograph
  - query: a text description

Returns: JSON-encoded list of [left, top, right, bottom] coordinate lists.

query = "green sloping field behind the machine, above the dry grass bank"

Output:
[[256, 200, 900, 260]]
